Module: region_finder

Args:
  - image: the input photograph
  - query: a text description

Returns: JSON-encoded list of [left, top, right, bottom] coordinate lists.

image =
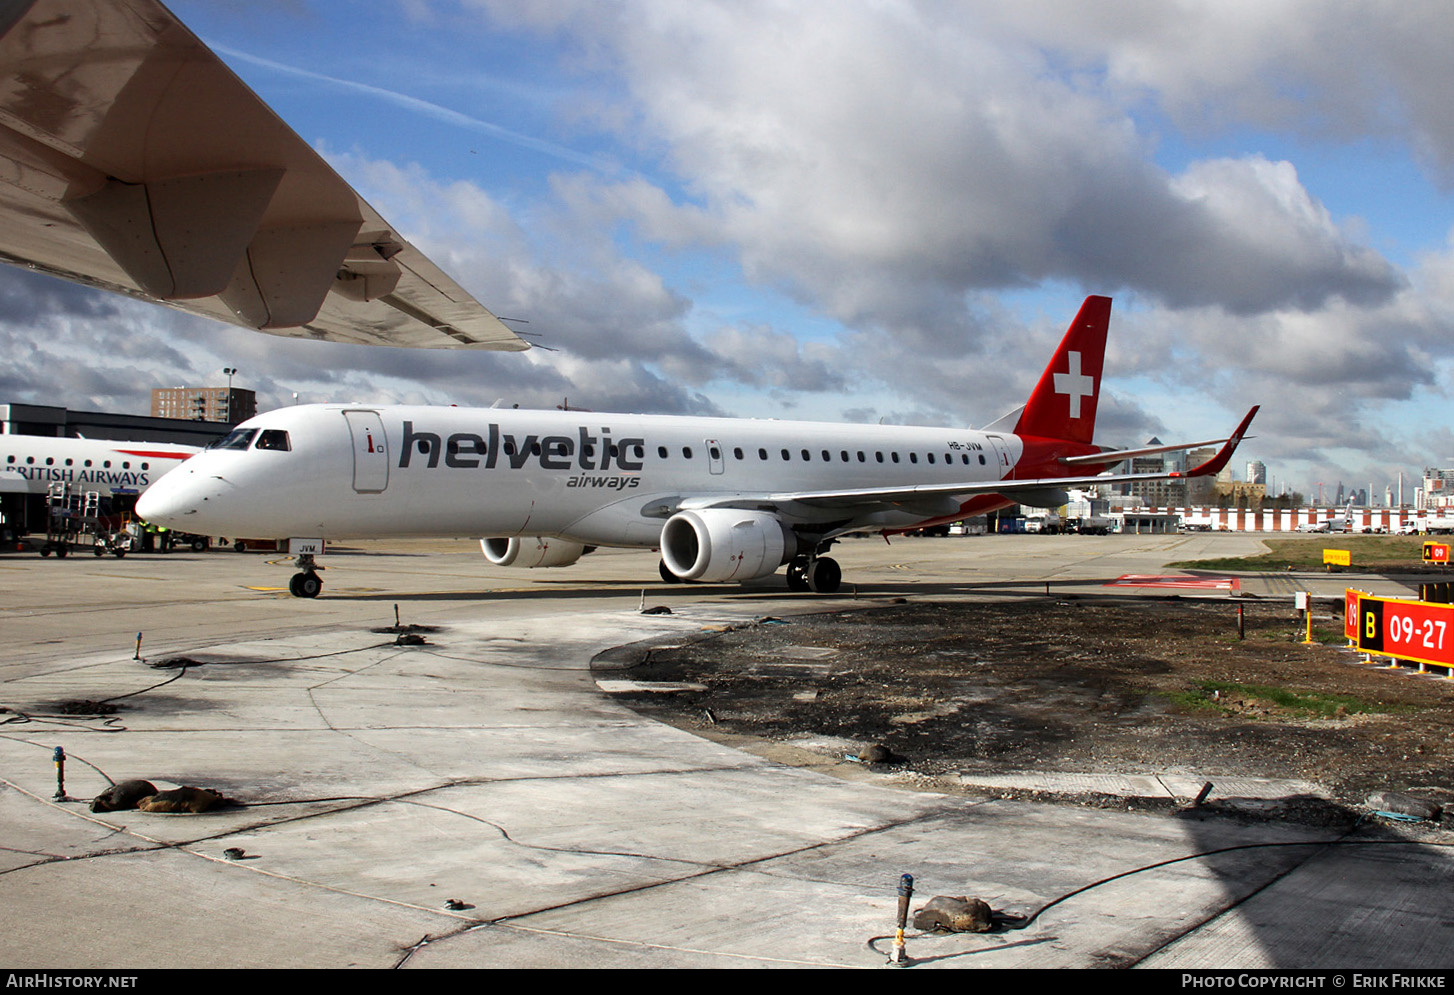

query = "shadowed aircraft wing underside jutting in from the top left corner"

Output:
[[0, 0, 529, 351]]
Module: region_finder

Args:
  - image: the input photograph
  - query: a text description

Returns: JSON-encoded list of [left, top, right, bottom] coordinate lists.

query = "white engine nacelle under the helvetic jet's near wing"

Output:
[[662, 508, 798, 583]]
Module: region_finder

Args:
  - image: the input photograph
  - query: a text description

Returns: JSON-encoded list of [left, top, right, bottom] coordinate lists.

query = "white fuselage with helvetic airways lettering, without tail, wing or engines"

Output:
[[138, 404, 1021, 547]]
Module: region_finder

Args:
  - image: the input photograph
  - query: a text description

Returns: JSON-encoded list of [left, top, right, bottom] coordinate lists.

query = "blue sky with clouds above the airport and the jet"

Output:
[[8, 0, 1454, 493]]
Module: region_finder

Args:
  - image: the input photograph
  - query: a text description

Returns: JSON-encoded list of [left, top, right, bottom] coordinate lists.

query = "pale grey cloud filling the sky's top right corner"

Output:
[[973, 0, 1454, 186]]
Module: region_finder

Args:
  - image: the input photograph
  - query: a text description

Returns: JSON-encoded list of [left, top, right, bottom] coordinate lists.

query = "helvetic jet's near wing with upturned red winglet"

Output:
[[679, 407, 1258, 511]]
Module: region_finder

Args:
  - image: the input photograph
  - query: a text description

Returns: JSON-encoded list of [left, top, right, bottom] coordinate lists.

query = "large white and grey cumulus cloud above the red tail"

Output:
[[491, 0, 1400, 322]]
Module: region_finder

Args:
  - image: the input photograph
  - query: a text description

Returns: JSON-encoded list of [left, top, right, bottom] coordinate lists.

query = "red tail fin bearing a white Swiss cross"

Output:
[[1015, 297, 1111, 442]]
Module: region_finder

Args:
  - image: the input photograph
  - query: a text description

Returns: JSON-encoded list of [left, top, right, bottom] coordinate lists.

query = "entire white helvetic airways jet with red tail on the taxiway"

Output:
[[137, 290, 1256, 598]]
